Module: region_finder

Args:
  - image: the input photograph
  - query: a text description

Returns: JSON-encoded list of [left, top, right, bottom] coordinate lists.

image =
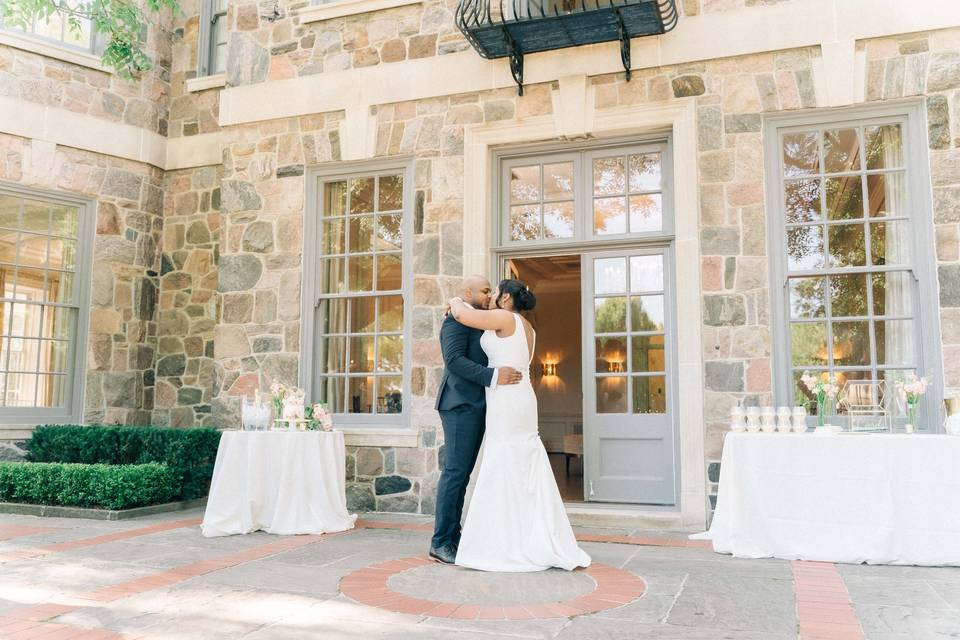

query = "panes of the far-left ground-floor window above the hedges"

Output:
[[0, 192, 81, 413]]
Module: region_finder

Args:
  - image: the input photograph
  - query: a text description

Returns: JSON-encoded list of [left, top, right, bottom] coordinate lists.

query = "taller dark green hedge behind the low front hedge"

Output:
[[26, 425, 220, 500]]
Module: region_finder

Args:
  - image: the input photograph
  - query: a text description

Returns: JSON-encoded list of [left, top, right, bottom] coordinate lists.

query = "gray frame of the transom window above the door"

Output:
[[491, 136, 674, 252]]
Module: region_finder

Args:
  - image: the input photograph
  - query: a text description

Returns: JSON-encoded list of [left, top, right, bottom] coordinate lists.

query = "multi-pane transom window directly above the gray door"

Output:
[[501, 144, 672, 245]]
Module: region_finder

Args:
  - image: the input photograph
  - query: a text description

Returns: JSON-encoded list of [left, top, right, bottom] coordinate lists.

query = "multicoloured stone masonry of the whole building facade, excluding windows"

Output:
[[0, 0, 960, 513]]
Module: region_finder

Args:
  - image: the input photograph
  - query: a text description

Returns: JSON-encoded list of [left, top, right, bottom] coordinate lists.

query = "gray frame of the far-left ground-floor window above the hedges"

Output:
[[0, 182, 97, 425]]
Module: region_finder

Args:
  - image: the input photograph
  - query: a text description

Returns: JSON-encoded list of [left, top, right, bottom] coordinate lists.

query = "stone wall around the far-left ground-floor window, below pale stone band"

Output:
[[0, 134, 164, 424]]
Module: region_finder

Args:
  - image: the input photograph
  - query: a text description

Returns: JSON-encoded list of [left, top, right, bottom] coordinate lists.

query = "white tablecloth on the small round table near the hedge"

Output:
[[201, 431, 357, 538]]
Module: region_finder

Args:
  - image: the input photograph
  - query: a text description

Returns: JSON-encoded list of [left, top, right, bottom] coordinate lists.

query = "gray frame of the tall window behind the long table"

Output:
[[763, 100, 943, 432]]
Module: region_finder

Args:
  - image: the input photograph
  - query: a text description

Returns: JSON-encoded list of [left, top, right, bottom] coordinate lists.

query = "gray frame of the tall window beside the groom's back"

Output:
[[299, 159, 415, 428]]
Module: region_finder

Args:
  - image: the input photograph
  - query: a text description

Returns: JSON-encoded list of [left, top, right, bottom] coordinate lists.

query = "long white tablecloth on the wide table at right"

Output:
[[697, 433, 960, 566]]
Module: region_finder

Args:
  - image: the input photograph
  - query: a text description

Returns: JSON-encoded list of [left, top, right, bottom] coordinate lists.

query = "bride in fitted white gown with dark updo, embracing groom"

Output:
[[450, 280, 590, 571]]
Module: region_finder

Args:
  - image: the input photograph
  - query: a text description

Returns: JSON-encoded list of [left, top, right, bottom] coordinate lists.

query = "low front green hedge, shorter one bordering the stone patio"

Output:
[[0, 462, 180, 509]]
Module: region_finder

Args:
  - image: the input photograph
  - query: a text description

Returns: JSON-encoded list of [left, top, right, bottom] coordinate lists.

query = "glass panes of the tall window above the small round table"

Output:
[[314, 172, 404, 415]]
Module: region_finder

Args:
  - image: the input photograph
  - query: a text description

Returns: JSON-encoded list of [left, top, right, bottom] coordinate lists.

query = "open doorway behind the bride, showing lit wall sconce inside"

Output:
[[506, 255, 584, 502]]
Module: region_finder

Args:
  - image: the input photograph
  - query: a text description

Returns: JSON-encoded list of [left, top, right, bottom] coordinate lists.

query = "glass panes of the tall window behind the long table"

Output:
[[779, 120, 922, 410]]
